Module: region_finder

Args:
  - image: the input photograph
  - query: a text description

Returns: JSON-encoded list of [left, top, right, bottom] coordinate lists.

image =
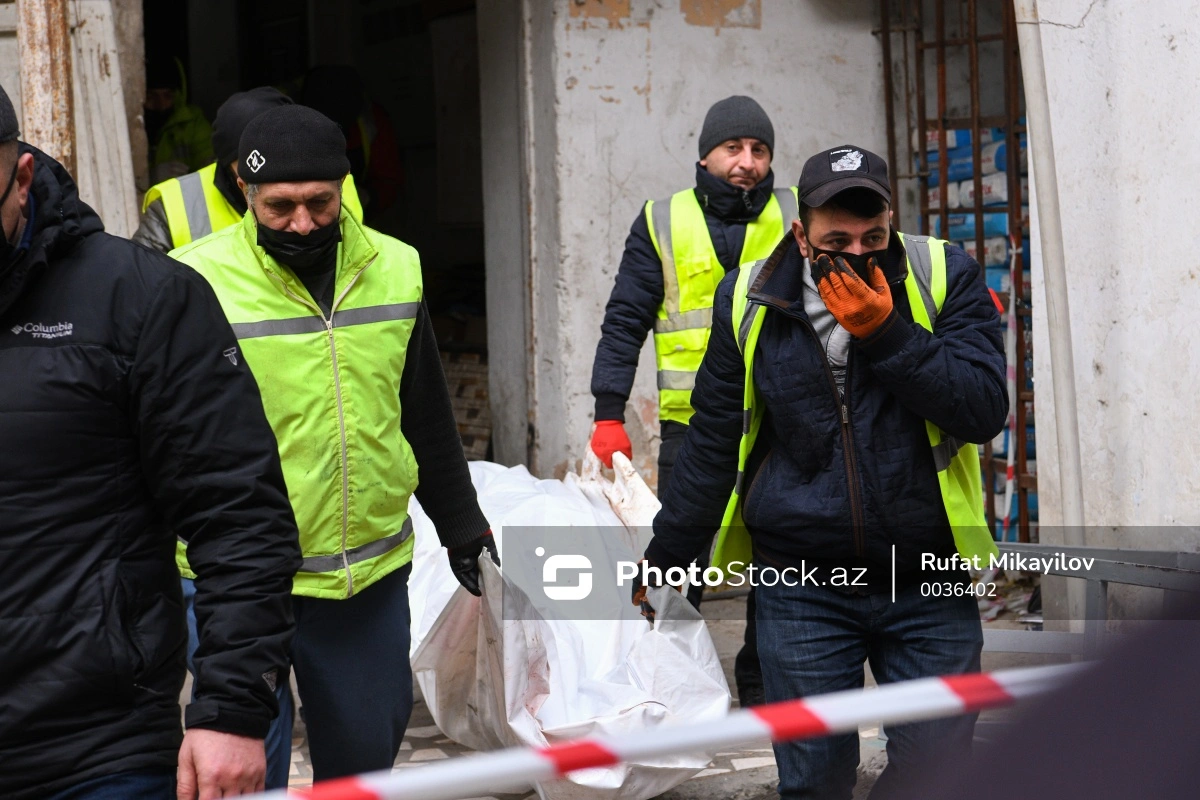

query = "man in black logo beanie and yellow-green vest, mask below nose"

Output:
[[166, 106, 498, 781]]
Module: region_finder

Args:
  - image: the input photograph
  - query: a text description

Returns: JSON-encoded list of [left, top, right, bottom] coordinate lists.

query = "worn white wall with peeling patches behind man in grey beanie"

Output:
[[480, 0, 886, 475]]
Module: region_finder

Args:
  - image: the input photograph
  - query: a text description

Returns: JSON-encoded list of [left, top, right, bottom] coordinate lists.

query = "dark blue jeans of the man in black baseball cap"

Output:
[[756, 575, 983, 800]]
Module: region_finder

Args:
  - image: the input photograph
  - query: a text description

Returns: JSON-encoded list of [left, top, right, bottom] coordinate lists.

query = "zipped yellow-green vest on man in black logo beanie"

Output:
[[170, 206, 422, 600]]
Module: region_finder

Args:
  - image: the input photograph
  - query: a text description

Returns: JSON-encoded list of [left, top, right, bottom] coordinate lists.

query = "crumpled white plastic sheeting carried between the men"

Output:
[[409, 462, 730, 800]]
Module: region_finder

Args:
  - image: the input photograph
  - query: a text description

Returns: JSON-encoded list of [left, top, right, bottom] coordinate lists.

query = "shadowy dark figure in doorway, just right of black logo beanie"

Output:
[[300, 64, 404, 219]]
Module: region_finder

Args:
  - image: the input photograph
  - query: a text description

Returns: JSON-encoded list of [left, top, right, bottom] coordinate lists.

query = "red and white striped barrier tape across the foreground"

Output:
[[257, 664, 1081, 800]]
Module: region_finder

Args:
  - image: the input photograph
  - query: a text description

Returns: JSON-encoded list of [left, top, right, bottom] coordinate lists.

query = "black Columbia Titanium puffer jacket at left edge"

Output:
[[0, 145, 300, 799]]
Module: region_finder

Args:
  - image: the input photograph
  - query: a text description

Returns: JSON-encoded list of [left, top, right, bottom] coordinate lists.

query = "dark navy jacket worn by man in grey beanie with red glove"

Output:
[[592, 163, 775, 422]]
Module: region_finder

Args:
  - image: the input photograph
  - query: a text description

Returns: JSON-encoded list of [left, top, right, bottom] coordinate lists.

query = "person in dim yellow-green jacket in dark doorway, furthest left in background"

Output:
[[143, 58, 212, 184]]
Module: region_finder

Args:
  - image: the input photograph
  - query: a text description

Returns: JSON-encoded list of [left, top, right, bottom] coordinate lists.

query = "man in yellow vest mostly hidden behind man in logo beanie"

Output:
[[133, 86, 362, 253]]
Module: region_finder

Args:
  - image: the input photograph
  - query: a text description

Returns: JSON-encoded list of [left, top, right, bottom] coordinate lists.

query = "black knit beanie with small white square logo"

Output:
[[238, 106, 350, 184]]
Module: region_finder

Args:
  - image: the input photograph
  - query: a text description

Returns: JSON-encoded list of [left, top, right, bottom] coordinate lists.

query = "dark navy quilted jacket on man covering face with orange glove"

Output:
[[647, 234, 1008, 575]]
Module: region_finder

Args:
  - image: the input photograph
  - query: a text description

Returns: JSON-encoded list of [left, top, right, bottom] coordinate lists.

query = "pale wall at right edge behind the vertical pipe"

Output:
[[1031, 0, 1200, 615]]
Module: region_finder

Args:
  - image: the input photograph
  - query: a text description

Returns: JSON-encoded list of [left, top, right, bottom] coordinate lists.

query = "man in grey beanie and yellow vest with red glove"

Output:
[[592, 95, 797, 705]]
